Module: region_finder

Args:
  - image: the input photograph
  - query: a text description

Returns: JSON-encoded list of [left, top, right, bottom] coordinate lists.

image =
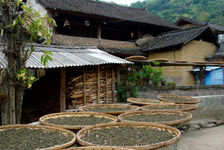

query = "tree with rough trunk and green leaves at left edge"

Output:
[[0, 0, 56, 125]]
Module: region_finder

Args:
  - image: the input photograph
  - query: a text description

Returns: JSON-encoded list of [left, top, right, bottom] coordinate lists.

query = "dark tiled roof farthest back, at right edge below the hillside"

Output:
[[175, 16, 224, 32]]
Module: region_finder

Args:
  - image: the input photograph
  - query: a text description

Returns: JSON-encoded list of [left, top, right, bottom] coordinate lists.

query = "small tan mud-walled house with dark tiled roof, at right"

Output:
[[143, 25, 217, 85]]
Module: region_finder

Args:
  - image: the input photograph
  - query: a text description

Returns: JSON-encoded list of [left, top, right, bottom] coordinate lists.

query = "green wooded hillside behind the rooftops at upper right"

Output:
[[131, 0, 224, 25]]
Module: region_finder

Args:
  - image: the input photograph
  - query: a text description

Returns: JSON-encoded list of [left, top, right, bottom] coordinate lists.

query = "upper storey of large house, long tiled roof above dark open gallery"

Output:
[[27, 0, 178, 58]]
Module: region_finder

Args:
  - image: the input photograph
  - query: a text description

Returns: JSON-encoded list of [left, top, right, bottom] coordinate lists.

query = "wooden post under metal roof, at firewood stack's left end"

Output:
[[60, 68, 66, 112]]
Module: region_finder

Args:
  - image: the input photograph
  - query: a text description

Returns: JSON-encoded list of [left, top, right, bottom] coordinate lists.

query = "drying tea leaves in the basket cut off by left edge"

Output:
[[0, 128, 73, 150]]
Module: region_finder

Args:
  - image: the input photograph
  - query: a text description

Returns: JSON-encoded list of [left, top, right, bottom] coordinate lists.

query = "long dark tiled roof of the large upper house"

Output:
[[38, 0, 178, 29]]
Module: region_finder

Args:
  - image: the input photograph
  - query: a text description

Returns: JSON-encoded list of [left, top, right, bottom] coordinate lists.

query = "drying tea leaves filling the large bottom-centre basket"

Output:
[[81, 126, 174, 146]]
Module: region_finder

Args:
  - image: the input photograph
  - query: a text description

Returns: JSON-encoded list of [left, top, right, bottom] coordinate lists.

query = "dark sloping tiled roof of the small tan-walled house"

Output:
[[142, 26, 216, 52]]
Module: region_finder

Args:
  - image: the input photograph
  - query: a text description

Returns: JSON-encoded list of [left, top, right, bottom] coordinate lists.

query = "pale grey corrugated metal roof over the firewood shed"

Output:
[[0, 45, 132, 69]]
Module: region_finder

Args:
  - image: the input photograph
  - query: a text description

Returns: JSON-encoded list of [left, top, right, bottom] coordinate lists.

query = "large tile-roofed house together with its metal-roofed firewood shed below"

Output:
[[1, 0, 179, 123]]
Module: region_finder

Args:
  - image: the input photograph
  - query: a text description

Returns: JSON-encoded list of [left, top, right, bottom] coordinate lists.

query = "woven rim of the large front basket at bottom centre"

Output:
[[77, 122, 181, 150]]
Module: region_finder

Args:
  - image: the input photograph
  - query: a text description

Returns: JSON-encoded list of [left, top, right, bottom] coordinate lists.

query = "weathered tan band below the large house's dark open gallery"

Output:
[[52, 34, 144, 57]]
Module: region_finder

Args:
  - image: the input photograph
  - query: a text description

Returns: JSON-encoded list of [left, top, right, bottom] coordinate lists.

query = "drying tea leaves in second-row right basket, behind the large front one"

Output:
[[123, 113, 185, 122]]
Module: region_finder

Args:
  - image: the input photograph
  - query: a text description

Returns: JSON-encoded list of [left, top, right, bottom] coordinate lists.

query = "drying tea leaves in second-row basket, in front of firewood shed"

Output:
[[44, 115, 113, 126]]
